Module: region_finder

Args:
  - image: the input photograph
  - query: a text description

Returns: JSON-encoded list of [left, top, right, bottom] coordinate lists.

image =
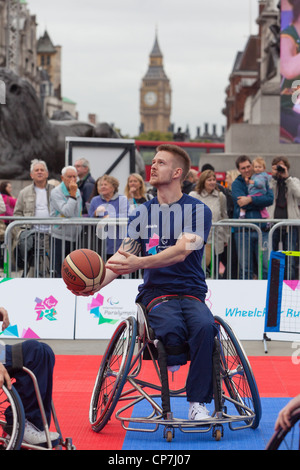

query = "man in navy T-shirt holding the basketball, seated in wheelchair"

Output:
[[101, 145, 217, 420]]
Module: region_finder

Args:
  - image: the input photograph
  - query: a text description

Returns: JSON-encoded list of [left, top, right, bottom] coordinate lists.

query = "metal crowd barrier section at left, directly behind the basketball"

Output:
[[2, 217, 127, 278]]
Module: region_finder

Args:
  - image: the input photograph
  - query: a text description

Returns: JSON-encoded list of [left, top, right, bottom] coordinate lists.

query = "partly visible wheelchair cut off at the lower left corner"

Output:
[[0, 366, 75, 450]]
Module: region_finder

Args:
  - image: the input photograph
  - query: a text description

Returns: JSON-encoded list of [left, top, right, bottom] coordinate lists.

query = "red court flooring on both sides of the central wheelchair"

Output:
[[53, 355, 300, 450]]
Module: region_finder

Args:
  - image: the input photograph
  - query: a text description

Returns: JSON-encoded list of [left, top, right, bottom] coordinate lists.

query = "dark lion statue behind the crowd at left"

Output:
[[0, 68, 144, 180]]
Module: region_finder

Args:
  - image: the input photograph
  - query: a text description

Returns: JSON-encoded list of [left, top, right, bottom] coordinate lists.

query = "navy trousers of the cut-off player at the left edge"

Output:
[[5, 340, 55, 430]]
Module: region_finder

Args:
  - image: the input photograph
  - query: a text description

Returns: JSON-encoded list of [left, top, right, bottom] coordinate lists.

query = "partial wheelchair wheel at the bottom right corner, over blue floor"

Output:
[[266, 408, 300, 450]]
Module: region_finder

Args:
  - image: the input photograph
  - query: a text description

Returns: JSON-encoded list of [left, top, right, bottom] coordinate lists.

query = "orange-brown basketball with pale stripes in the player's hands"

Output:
[[61, 248, 105, 296]]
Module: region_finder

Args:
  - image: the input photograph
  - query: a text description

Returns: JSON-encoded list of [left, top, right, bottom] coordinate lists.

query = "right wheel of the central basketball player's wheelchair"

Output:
[[214, 317, 261, 429]]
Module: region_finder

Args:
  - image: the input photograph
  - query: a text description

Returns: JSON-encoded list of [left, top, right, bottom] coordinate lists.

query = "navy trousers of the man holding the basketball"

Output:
[[148, 297, 217, 403]]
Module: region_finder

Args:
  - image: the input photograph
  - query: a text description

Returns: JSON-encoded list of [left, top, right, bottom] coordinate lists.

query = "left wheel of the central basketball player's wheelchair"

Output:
[[89, 317, 137, 432]]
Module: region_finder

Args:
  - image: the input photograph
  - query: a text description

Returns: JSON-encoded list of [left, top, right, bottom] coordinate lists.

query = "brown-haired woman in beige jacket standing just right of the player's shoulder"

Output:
[[190, 170, 228, 277]]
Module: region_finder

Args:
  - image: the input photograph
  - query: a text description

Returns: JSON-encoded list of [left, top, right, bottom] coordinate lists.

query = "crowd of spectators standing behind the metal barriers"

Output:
[[0, 155, 300, 279]]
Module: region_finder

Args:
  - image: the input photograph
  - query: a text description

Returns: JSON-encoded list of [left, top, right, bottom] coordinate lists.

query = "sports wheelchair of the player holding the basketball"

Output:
[[89, 304, 261, 442]]
